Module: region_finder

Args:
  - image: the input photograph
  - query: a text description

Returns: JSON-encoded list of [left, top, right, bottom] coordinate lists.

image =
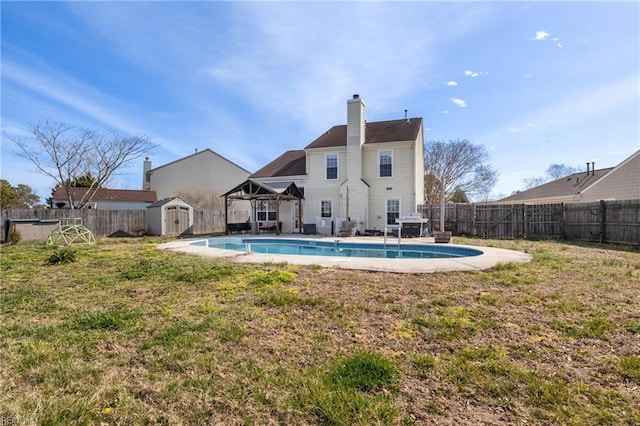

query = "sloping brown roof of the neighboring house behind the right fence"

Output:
[[499, 167, 613, 203]]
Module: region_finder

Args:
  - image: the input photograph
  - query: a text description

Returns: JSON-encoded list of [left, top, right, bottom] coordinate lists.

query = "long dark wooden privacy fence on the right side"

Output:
[[418, 200, 640, 245]]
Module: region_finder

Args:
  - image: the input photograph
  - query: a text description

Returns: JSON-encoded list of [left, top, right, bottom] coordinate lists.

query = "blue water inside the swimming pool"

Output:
[[192, 237, 482, 259]]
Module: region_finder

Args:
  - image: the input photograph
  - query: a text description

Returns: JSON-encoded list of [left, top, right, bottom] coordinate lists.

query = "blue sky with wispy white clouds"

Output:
[[0, 1, 640, 200]]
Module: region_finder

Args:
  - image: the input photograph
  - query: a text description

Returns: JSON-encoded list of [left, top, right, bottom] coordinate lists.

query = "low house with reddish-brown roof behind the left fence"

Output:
[[52, 188, 158, 210]]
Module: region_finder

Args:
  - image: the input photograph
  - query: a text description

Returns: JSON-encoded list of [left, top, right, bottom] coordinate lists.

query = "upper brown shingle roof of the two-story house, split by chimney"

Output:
[[305, 117, 422, 149]]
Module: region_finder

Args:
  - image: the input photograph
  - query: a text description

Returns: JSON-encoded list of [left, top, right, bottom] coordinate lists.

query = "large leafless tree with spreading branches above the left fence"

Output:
[[8, 120, 157, 209]]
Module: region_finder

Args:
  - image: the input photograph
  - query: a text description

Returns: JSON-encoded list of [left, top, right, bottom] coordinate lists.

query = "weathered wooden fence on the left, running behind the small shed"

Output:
[[0, 209, 224, 241]]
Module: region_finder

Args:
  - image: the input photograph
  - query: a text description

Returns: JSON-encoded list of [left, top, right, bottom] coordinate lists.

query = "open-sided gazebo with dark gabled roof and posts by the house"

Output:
[[222, 179, 304, 235]]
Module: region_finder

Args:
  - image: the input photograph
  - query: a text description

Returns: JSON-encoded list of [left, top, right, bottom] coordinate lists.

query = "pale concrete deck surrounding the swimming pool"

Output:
[[158, 234, 533, 273]]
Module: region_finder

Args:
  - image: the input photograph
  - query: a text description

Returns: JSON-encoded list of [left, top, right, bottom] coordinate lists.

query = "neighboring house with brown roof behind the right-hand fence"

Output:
[[497, 151, 640, 204]]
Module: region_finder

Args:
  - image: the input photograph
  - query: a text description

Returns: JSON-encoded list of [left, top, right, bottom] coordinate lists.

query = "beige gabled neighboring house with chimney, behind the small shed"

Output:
[[143, 148, 251, 222]]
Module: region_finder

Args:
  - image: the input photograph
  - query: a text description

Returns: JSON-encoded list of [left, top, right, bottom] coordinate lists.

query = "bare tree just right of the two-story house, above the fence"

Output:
[[424, 139, 498, 204]]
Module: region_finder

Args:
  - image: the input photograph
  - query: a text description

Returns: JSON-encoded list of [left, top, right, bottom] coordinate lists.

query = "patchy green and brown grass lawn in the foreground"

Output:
[[0, 238, 640, 425]]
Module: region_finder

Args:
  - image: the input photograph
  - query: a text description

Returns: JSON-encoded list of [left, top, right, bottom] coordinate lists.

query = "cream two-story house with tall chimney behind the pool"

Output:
[[250, 95, 424, 234]]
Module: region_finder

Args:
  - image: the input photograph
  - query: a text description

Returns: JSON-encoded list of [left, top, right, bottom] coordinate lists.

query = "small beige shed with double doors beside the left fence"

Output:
[[147, 197, 193, 235]]
